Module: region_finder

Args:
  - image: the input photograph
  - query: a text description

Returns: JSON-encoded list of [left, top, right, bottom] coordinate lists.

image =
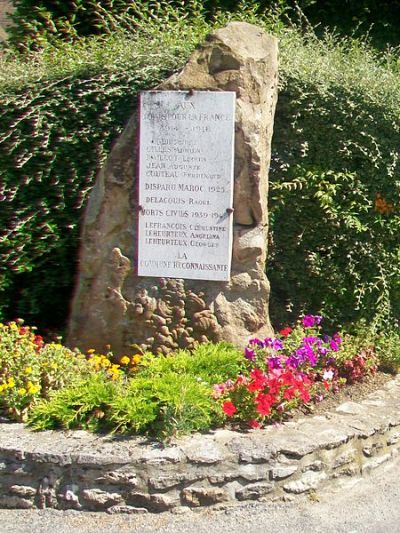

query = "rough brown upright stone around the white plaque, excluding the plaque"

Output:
[[68, 22, 278, 354]]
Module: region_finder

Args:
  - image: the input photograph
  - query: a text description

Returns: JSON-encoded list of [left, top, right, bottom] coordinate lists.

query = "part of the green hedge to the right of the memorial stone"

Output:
[[268, 31, 400, 326]]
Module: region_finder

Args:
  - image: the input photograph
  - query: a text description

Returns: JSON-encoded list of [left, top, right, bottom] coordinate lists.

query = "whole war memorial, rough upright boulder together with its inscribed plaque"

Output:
[[68, 22, 278, 354]]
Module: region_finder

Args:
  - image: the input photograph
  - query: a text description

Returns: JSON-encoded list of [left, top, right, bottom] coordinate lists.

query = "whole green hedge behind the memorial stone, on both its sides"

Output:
[[0, 1, 400, 327]]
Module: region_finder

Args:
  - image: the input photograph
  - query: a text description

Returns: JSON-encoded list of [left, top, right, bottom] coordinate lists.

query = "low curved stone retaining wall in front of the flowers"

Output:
[[0, 372, 400, 513]]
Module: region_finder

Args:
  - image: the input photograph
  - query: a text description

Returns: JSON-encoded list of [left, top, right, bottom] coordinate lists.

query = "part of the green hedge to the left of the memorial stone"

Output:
[[0, 7, 211, 327]]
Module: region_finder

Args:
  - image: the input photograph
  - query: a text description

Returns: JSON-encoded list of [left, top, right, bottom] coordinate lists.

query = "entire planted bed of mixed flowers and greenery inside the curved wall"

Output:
[[0, 315, 392, 440]]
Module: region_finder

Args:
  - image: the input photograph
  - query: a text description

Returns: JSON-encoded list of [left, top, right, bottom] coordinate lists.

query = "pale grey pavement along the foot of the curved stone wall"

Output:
[[0, 459, 400, 533]]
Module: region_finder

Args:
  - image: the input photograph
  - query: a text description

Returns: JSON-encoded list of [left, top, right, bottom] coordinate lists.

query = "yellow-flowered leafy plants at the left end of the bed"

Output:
[[0, 322, 89, 420]]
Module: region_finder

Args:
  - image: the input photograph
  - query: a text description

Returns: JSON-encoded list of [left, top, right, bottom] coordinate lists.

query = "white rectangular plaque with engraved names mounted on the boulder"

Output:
[[138, 91, 236, 281]]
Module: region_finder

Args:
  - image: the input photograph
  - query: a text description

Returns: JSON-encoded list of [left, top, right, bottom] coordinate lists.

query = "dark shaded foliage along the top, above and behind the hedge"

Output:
[[11, 0, 400, 49]]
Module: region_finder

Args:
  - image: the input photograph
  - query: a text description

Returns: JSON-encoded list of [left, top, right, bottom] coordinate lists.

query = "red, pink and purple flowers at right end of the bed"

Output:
[[214, 315, 378, 428]]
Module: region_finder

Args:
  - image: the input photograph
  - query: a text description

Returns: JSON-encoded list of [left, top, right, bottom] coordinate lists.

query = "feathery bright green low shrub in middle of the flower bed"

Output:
[[30, 343, 243, 440]]
